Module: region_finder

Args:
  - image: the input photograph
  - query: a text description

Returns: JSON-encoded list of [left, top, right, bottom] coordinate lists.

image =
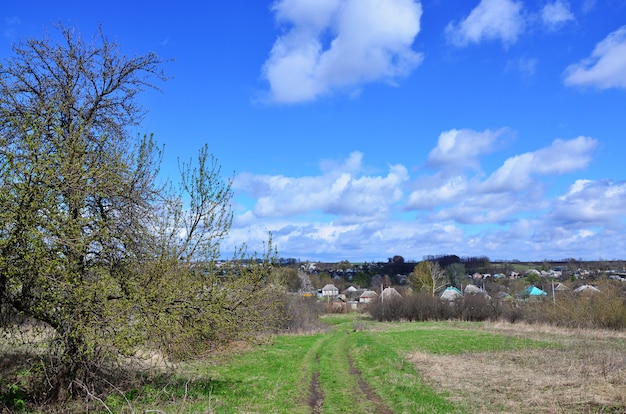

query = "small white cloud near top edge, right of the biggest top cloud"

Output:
[[446, 0, 525, 46]]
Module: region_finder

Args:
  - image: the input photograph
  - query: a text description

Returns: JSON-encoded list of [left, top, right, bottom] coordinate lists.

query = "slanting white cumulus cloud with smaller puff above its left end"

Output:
[[405, 135, 597, 224]]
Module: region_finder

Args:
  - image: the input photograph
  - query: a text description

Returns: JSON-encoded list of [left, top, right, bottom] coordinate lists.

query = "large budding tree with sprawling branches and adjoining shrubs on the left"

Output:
[[0, 26, 276, 399]]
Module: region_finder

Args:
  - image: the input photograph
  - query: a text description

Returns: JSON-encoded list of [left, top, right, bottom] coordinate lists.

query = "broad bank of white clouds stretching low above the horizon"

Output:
[[224, 130, 626, 261]]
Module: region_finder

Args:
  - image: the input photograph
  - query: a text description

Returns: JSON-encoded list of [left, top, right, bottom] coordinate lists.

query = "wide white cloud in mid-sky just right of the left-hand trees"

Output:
[[233, 152, 408, 222]]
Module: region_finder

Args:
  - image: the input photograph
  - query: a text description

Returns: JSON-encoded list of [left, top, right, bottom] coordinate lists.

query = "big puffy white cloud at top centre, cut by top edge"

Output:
[[263, 0, 422, 103]]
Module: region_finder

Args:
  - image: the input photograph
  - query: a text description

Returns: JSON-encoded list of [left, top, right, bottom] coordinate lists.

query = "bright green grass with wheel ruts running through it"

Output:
[[106, 314, 550, 413]]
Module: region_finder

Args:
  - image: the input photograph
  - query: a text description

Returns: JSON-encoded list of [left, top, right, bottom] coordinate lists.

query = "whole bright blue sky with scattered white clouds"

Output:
[[0, 0, 626, 261]]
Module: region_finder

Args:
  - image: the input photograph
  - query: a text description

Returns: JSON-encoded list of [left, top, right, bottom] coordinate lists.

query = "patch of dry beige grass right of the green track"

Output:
[[411, 324, 626, 413]]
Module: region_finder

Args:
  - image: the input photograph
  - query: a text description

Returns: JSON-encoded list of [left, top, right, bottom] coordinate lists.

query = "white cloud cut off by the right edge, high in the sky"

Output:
[[565, 26, 626, 89]]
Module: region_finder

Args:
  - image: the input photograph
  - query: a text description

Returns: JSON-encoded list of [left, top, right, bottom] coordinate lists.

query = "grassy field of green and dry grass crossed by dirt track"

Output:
[[94, 314, 626, 413]]
